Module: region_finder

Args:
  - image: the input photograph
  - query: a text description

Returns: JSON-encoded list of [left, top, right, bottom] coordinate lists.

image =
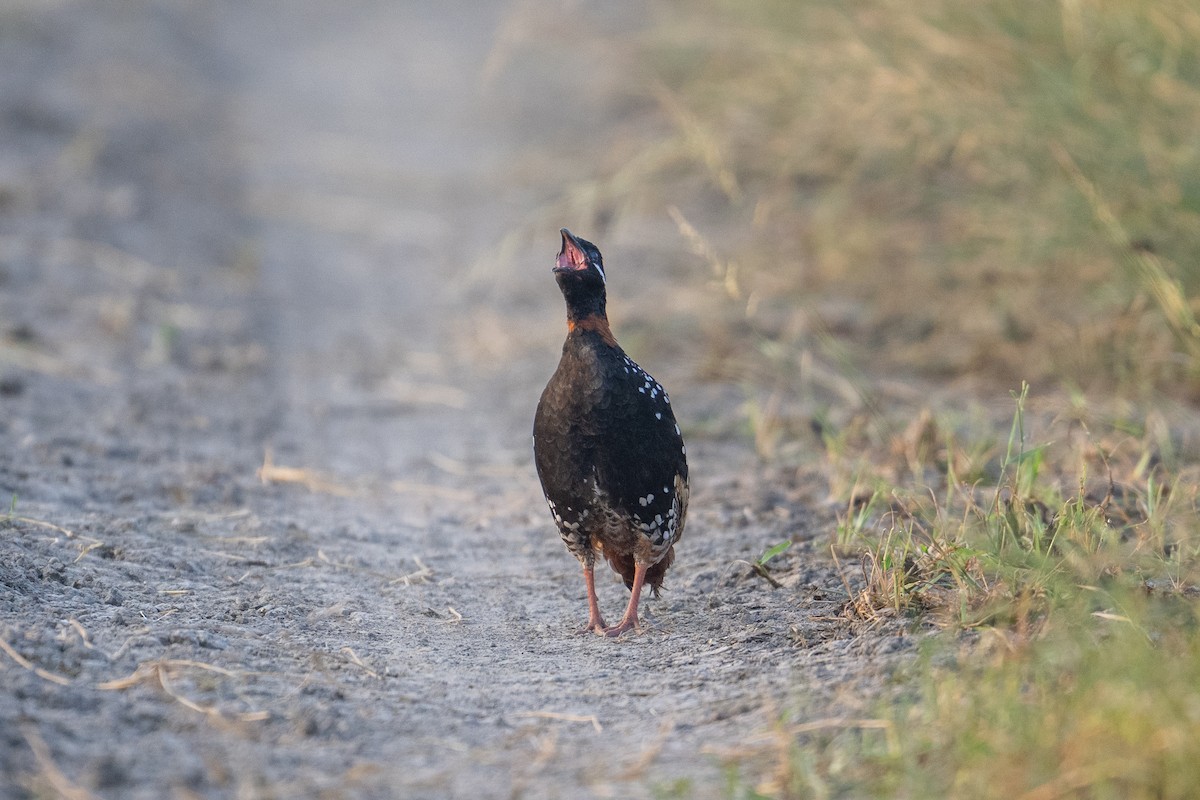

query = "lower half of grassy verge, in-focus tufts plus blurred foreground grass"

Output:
[[710, 387, 1200, 799]]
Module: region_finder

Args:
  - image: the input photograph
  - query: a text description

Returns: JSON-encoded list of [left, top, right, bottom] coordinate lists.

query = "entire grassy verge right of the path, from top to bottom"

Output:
[[604, 0, 1200, 800]]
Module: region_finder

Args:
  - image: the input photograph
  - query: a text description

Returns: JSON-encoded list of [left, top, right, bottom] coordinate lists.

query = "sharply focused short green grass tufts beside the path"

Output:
[[828, 385, 1200, 627]]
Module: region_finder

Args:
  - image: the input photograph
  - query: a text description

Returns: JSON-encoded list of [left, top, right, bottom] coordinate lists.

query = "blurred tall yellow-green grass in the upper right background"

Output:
[[590, 0, 1200, 401]]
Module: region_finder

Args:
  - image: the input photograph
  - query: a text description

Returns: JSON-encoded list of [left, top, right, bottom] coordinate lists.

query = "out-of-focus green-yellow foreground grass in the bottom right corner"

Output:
[[748, 593, 1200, 800]]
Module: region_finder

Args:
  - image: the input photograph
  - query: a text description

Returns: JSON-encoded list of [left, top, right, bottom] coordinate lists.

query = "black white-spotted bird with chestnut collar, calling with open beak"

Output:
[[533, 228, 688, 637]]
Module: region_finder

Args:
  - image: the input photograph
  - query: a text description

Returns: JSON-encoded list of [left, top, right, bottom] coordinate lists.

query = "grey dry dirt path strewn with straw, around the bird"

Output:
[[0, 2, 908, 798]]
